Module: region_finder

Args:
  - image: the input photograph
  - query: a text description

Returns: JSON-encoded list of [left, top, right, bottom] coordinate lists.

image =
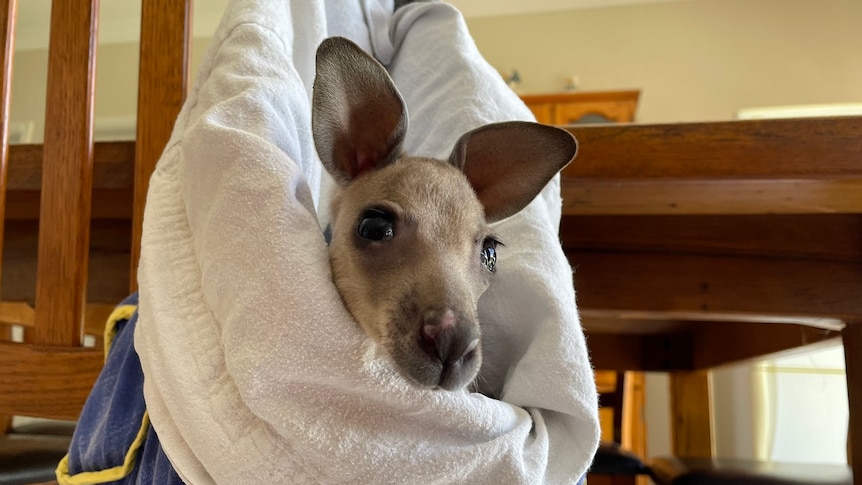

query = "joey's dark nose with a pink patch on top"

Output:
[[420, 308, 479, 366]]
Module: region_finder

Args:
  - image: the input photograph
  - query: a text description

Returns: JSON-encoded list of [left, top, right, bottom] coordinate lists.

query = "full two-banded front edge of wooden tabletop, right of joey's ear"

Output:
[[562, 117, 862, 215]]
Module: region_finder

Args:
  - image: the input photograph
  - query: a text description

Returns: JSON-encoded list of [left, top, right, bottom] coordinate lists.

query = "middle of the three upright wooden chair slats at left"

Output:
[[35, 0, 99, 346]]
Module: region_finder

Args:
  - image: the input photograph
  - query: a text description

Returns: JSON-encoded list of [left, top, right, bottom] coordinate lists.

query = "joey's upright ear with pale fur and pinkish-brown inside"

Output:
[[311, 37, 407, 185]]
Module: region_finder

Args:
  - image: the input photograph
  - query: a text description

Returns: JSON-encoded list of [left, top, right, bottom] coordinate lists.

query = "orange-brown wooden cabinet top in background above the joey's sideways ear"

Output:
[[521, 90, 640, 125]]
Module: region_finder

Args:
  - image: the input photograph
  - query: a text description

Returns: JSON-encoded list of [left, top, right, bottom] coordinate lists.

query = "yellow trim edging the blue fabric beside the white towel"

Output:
[[54, 305, 150, 485]]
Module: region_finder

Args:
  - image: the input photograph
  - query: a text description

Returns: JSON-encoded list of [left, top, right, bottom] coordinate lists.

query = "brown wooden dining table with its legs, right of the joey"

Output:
[[560, 117, 862, 476]]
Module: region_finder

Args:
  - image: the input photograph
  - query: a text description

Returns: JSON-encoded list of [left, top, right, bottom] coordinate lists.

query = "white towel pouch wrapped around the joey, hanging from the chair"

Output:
[[135, 0, 599, 484]]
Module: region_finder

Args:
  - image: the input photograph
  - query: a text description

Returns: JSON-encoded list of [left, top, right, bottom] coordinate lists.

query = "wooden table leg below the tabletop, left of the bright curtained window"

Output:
[[670, 371, 715, 458]]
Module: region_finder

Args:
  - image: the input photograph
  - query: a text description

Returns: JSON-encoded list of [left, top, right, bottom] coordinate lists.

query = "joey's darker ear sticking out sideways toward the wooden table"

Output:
[[449, 121, 578, 222]]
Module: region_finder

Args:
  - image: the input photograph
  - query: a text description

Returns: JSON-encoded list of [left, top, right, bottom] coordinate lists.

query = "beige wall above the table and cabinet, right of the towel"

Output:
[[467, 0, 862, 122]]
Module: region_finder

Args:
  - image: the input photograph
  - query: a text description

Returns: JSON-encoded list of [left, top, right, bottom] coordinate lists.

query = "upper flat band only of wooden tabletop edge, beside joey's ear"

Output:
[[563, 116, 862, 180]]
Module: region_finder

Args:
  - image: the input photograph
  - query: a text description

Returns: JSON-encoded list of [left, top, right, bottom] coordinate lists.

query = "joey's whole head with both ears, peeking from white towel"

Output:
[[312, 37, 577, 390]]
